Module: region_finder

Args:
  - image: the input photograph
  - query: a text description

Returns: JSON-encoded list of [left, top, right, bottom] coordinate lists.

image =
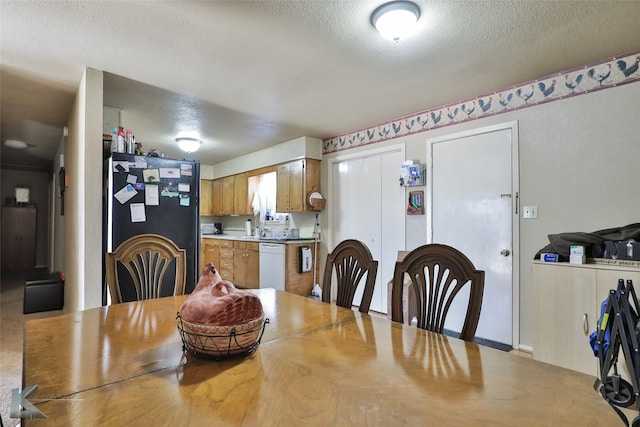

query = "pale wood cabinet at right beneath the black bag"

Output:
[[532, 261, 640, 376]]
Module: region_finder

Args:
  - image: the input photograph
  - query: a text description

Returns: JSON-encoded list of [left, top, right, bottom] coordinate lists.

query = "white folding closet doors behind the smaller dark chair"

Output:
[[328, 150, 405, 313]]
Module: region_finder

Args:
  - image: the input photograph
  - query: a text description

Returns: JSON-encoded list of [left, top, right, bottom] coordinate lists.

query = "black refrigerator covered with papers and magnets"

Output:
[[102, 153, 200, 304]]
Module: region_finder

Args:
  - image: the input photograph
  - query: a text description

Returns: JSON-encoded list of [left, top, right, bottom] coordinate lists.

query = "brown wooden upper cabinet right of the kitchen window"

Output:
[[276, 159, 320, 213]]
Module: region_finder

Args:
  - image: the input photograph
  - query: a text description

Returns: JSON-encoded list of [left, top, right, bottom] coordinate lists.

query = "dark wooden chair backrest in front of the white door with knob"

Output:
[[391, 244, 484, 341]]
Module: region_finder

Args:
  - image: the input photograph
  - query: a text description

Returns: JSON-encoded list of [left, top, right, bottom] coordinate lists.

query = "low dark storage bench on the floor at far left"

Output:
[[24, 271, 64, 314]]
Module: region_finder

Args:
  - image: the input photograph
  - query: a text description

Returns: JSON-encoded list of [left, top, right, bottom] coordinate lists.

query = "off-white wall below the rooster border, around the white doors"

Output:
[[322, 82, 640, 347]]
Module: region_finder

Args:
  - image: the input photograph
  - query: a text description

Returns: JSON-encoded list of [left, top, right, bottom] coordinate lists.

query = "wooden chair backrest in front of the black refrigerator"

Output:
[[106, 234, 187, 304]]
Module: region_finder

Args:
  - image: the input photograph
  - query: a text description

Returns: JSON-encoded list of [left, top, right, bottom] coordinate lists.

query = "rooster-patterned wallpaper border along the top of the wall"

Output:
[[322, 51, 640, 154]]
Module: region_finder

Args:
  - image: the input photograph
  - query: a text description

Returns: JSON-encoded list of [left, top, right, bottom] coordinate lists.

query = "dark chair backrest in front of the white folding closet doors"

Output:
[[322, 239, 378, 313]]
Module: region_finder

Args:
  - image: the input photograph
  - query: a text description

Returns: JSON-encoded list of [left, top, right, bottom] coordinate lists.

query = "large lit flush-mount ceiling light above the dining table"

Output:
[[371, 1, 420, 43]]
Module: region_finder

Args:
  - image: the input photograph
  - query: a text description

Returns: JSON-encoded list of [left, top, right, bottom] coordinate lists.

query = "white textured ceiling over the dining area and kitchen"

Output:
[[0, 0, 640, 172]]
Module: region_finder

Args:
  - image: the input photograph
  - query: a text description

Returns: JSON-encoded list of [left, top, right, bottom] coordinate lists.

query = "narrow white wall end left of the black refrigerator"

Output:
[[60, 68, 104, 312]]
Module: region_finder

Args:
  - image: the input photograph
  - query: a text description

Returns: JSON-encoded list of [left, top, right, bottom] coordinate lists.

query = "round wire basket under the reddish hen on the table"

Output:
[[178, 313, 269, 359]]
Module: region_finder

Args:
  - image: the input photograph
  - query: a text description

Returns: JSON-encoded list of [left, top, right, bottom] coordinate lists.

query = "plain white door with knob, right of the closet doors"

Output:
[[427, 124, 518, 346]]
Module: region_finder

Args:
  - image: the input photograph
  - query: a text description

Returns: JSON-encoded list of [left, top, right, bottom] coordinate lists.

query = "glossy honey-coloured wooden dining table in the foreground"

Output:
[[23, 288, 622, 427]]
